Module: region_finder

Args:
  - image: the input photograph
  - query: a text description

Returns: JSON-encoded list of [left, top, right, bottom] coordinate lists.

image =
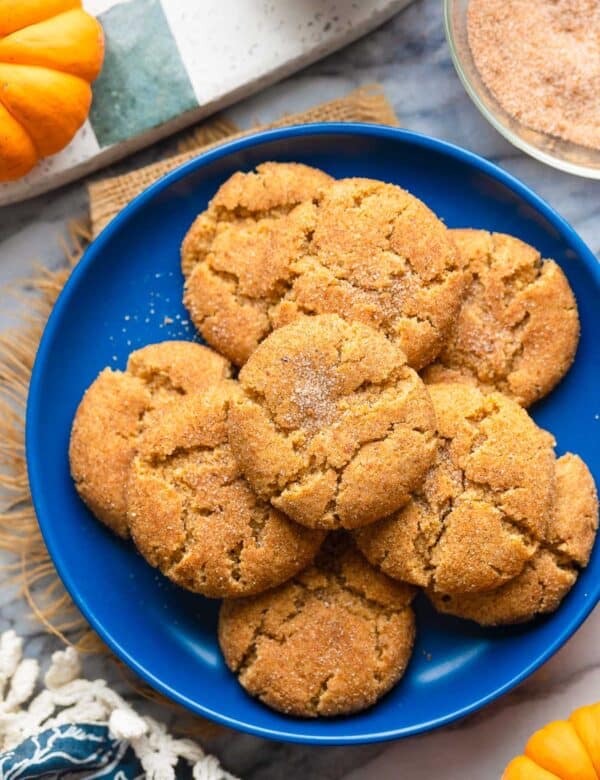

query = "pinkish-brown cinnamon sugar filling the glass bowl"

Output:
[[467, 0, 600, 149]]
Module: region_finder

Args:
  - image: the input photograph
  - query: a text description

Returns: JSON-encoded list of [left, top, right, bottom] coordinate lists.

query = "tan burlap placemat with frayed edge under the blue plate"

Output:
[[0, 86, 398, 735]]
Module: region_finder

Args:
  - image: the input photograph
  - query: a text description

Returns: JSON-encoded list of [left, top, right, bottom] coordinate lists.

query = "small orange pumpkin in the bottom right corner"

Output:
[[502, 702, 600, 780]]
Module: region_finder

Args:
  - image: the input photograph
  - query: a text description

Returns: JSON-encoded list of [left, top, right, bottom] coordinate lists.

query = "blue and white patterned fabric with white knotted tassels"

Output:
[[0, 629, 237, 780]]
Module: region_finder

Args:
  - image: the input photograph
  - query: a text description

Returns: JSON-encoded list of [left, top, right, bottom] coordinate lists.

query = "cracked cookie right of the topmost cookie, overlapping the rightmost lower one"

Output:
[[355, 384, 554, 593]]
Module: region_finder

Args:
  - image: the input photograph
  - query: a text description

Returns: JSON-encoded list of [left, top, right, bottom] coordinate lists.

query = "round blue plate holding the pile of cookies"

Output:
[[27, 124, 600, 744]]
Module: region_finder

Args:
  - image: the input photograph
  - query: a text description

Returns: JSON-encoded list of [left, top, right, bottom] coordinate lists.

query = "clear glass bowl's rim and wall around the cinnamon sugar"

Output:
[[444, 0, 600, 179]]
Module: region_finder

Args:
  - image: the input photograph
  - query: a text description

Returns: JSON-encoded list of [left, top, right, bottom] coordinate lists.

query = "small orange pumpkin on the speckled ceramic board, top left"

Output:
[[0, 0, 104, 181]]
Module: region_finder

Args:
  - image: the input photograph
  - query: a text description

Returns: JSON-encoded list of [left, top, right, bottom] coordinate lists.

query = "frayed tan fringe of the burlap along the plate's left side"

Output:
[[0, 222, 227, 739]]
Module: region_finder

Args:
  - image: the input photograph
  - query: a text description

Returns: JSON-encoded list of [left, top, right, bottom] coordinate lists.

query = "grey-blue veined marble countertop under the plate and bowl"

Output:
[[0, 0, 600, 780]]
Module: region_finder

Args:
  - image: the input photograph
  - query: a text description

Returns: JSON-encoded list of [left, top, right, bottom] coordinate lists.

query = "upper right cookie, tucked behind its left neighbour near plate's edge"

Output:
[[424, 230, 579, 406]]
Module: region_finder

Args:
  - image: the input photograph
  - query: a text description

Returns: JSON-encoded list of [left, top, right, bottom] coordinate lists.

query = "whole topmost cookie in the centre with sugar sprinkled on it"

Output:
[[229, 315, 436, 529]]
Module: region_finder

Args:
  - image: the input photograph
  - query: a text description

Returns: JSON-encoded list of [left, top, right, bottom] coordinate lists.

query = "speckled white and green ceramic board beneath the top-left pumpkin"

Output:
[[0, 0, 410, 206]]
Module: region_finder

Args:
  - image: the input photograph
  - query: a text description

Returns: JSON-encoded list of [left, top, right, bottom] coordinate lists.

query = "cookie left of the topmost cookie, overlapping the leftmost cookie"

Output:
[[127, 381, 325, 598]]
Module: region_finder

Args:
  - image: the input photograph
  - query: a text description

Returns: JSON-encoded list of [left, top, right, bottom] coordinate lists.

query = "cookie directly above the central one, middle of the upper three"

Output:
[[271, 178, 464, 369]]
